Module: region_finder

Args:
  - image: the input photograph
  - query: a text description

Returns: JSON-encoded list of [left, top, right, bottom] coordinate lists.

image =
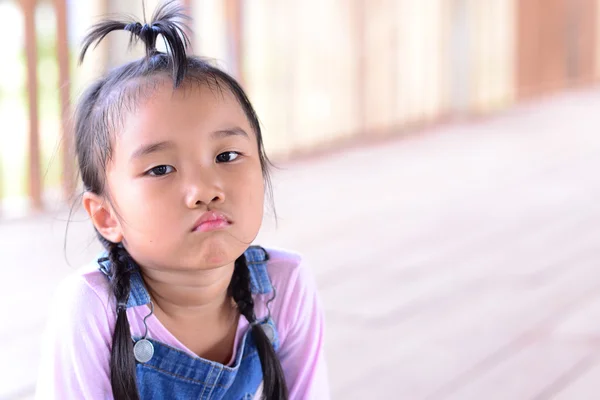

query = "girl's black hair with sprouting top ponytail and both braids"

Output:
[[75, 1, 288, 400]]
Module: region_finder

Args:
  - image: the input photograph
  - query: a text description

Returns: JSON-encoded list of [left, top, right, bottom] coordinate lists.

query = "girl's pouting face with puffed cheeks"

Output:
[[96, 81, 264, 269]]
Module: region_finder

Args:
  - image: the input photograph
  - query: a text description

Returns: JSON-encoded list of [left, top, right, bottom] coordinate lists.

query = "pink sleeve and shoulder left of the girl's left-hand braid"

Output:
[[37, 264, 115, 399]]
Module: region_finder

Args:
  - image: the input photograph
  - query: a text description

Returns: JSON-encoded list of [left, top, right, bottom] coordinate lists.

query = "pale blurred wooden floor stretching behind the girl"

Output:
[[0, 91, 600, 400]]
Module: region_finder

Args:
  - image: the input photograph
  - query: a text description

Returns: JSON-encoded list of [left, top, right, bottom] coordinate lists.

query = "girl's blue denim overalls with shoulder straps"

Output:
[[99, 246, 279, 400]]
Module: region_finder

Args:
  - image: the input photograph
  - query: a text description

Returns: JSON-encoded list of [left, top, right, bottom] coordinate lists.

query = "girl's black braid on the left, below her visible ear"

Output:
[[98, 235, 140, 400]]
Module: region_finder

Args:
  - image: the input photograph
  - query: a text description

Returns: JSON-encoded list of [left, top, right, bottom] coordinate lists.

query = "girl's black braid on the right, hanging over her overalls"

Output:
[[229, 254, 288, 400]]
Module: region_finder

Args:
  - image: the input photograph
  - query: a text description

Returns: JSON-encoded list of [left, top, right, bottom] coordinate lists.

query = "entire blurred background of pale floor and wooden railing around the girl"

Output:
[[0, 0, 600, 400]]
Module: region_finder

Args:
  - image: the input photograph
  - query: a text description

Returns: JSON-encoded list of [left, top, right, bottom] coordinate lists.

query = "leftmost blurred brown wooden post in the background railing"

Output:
[[21, 0, 42, 211]]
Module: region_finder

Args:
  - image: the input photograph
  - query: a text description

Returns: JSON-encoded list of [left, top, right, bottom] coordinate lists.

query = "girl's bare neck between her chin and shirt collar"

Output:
[[142, 263, 234, 319]]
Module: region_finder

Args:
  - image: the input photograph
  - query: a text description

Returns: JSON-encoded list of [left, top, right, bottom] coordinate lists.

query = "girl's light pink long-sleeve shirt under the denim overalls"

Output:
[[36, 249, 329, 400]]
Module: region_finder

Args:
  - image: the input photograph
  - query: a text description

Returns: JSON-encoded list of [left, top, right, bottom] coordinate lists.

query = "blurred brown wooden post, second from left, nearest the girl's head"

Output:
[[54, 0, 75, 199]]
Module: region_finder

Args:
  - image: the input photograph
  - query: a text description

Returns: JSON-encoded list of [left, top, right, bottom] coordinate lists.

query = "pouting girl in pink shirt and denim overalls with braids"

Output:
[[37, 2, 328, 400]]
